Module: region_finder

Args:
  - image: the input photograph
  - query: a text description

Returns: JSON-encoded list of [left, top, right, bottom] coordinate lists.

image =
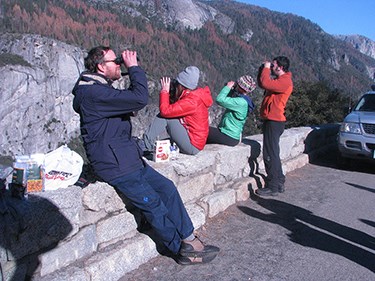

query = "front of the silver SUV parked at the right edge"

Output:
[[338, 91, 375, 160]]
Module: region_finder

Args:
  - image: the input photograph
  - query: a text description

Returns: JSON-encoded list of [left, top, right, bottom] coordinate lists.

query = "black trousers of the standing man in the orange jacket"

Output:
[[263, 120, 285, 191]]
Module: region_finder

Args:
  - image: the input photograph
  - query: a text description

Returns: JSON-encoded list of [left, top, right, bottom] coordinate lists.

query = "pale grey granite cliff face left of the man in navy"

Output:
[[0, 34, 84, 155]]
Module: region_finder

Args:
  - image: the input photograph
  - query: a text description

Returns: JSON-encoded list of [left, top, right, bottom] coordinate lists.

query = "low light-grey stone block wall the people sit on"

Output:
[[0, 125, 338, 281]]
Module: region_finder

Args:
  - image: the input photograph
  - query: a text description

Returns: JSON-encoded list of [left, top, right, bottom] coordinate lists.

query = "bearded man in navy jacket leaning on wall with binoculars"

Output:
[[73, 46, 219, 265]]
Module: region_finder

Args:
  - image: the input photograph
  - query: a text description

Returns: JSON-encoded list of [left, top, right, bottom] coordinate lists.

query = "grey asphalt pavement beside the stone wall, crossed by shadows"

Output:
[[120, 151, 375, 281]]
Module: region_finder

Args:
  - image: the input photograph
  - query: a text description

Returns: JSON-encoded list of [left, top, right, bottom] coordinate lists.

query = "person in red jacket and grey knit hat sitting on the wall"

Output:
[[143, 66, 213, 155]]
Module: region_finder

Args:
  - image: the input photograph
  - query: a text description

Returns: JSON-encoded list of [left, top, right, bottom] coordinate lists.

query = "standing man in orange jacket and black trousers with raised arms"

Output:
[[256, 56, 293, 196]]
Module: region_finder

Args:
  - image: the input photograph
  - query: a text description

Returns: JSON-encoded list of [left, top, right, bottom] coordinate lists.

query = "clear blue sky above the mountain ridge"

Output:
[[236, 0, 375, 41]]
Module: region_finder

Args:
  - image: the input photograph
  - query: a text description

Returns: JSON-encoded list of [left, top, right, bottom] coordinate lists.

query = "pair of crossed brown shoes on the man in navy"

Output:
[[178, 237, 220, 265]]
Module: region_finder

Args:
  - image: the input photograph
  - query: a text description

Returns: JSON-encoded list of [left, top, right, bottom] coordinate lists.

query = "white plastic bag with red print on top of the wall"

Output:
[[44, 145, 83, 191]]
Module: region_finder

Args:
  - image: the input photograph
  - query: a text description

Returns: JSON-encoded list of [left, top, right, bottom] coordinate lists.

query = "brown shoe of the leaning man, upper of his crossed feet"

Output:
[[179, 237, 220, 261]]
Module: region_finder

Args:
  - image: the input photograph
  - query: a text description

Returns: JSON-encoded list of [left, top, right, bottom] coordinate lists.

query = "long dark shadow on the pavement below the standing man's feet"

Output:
[[238, 189, 375, 272]]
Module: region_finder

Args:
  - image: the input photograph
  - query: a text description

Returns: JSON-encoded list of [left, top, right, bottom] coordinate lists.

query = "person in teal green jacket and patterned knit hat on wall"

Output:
[[207, 75, 256, 146]]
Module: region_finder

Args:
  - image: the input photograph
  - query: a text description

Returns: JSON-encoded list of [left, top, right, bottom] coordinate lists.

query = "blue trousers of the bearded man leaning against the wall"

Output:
[[109, 165, 194, 253]]
